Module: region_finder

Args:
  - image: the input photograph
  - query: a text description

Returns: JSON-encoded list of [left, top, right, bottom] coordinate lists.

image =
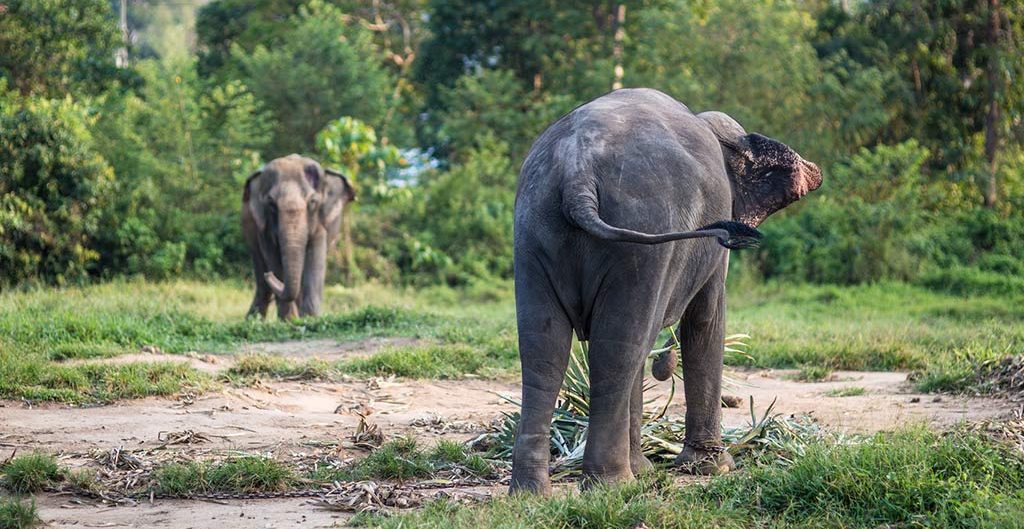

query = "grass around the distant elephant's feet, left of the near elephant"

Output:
[[0, 280, 518, 403]]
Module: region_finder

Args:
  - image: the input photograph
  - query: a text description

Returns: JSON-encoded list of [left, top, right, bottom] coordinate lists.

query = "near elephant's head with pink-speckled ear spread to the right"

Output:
[[697, 112, 821, 227]]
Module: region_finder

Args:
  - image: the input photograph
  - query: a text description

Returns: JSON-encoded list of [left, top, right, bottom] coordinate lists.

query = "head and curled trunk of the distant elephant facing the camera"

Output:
[[243, 155, 355, 309]]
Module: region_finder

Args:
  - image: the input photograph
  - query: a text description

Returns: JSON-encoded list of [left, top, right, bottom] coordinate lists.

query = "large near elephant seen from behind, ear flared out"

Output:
[[511, 89, 821, 493]]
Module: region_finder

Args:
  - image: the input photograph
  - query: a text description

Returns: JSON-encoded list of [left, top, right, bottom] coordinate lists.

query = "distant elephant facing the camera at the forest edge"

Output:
[[242, 155, 355, 319]]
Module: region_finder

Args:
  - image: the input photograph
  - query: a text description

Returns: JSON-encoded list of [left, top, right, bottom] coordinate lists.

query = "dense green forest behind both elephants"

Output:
[[0, 0, 1024, 294]]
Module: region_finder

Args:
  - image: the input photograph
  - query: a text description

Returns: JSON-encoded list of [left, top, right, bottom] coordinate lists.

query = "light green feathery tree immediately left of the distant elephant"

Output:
[[92, 60, 270, 277]]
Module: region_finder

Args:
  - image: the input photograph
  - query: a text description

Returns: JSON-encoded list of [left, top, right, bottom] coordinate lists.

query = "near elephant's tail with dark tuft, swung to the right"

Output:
[[562, 180, 761, 250]]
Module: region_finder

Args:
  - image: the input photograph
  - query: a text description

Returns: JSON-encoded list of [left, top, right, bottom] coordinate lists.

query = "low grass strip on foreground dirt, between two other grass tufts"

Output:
[[154, 456, 298, 495]]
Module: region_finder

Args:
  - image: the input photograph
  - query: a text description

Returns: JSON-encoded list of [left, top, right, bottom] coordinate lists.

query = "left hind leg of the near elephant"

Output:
[[509, 278, 572, 494]]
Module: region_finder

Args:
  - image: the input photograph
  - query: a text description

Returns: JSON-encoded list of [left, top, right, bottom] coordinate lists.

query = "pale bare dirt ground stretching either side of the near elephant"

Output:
[[0, 339, 1014, 529]]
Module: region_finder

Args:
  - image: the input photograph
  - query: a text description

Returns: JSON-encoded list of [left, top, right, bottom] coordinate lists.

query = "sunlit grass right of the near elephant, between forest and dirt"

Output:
[[728, 283, 1024, 391]]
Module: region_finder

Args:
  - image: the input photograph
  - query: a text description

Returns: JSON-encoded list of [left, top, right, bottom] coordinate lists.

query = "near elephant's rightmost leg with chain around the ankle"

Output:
[[676, 276, 735, 474]]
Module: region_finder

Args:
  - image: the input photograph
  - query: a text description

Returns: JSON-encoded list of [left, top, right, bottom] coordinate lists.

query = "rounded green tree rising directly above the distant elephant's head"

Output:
[[234, 1, 393, 158]]
